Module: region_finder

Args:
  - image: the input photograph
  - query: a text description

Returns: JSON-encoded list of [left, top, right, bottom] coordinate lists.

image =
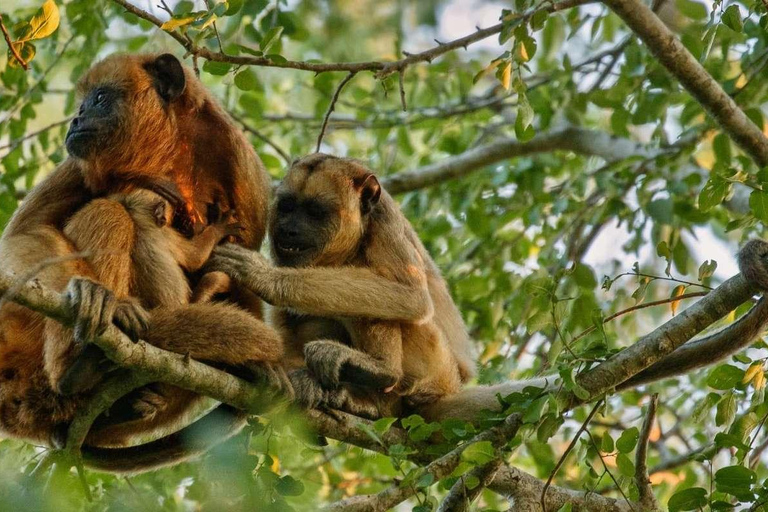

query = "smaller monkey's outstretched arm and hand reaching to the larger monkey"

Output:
[[207, 244, 433, 322]]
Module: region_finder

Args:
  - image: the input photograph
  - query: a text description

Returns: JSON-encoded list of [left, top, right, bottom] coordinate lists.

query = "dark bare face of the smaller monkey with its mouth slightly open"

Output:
[[269, 187, 339, 267]]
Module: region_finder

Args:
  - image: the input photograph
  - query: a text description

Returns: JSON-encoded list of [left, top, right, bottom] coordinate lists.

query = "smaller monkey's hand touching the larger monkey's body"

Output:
[[205, 244, 274, 294]]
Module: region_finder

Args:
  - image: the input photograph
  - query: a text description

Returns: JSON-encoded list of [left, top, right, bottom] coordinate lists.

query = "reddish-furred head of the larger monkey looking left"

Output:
[[66, 53, 196, 191]]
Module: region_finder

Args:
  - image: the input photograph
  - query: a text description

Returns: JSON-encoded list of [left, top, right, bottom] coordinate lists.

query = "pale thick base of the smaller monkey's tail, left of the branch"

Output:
[[418, 375, 559, 421]]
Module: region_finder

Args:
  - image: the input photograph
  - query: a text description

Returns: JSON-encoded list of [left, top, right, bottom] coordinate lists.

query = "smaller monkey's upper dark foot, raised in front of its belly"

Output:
[[304, 340, 399, 391]]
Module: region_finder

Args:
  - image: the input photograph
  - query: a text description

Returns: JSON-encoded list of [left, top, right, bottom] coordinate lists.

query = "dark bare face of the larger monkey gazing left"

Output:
[[66, 85, 124, 159]]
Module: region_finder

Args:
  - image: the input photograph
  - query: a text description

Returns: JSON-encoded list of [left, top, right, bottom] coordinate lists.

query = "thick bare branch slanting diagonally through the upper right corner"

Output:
[[603, 0, 768, 167]]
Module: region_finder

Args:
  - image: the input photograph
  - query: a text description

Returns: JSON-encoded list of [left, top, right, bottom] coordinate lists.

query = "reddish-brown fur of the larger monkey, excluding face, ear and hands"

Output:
[[0, 55, 282, 470]]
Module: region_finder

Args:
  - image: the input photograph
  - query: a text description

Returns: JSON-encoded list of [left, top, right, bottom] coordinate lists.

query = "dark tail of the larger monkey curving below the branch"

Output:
[[82, 404, 248, 474]]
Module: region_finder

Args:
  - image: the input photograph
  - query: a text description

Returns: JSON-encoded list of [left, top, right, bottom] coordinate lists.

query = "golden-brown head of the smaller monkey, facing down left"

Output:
[[269, 153, 381, 267]]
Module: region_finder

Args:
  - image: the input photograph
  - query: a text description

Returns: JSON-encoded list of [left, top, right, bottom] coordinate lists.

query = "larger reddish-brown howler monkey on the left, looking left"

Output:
[[0, 54, 282, 471]]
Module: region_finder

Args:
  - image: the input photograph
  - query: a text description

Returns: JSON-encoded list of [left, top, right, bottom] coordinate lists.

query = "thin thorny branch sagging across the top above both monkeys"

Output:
[[112, 0, 596, 78]]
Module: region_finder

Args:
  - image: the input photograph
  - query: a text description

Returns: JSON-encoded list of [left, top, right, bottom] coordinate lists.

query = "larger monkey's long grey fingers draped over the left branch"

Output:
[[63, 277, 149, 343]]
